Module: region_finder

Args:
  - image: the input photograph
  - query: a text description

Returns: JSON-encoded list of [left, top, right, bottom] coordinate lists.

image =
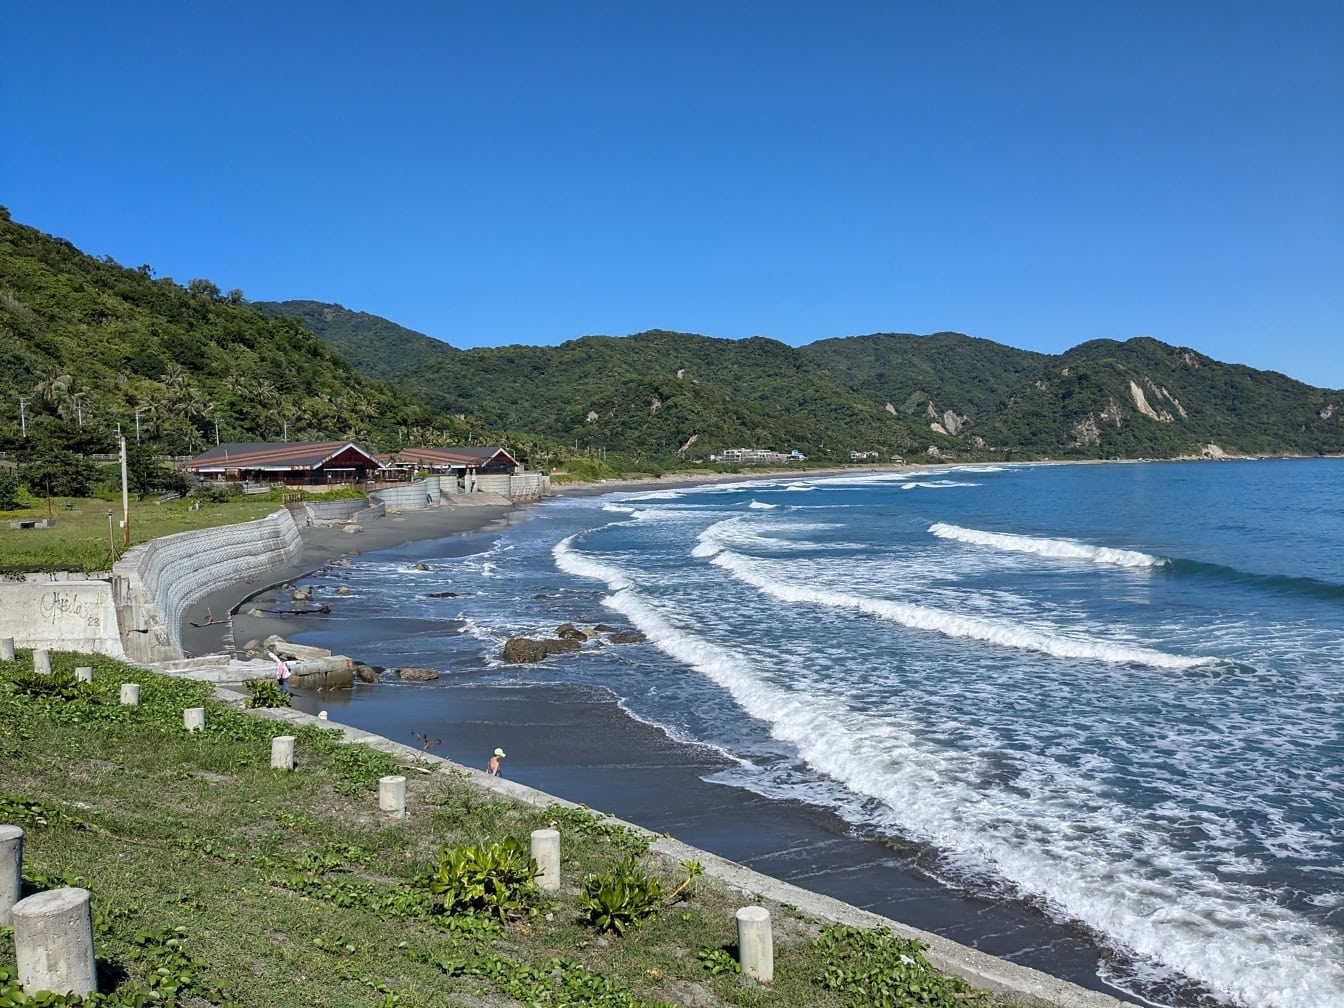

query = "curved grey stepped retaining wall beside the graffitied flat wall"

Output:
[[113, 509, 304, 661]]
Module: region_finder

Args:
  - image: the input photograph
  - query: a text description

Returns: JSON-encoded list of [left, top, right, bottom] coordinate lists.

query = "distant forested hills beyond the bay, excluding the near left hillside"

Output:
[[267, 295, 1344, 458]]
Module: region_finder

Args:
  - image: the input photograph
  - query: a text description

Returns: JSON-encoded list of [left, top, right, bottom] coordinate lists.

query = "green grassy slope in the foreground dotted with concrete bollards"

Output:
[[0, 652, 985, 1008]]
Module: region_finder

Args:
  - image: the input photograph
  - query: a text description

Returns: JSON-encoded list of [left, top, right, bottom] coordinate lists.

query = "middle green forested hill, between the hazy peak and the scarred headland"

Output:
[[407, 329, 927, 461]]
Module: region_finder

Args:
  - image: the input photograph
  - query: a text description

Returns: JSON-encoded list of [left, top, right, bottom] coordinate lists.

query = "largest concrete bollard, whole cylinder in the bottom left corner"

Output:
[[13, 887, 98, 997]]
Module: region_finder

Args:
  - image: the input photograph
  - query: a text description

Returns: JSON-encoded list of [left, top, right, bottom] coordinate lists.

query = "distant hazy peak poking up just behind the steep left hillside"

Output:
[[251, 301, 452, 378]]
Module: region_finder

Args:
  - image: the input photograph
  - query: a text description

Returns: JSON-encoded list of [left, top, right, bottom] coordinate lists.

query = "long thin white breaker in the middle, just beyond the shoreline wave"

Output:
[[694, 545, 1216, 669]]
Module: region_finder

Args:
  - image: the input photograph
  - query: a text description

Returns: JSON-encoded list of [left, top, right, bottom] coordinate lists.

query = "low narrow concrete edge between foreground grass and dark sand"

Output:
[[239, 687, 1132, 1008]]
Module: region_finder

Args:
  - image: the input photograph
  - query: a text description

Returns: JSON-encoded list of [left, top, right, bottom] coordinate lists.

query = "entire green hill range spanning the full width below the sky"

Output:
[[0, 207, 1344, 469]]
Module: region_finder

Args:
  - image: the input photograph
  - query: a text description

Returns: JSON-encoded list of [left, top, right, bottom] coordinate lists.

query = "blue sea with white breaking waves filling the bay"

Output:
[[299, 460, 1344, 1008]]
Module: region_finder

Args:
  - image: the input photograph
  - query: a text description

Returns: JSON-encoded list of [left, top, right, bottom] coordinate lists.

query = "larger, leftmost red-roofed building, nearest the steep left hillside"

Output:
[[183, 441, 383, 487]]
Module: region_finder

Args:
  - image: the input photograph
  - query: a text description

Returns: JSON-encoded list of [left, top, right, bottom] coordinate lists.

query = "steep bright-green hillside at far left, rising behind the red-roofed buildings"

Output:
[[0, 208, 465, 453]]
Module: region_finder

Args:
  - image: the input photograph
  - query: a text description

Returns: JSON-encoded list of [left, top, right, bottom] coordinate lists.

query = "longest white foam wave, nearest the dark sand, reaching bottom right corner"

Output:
[[555, 542, 1344, 1008]]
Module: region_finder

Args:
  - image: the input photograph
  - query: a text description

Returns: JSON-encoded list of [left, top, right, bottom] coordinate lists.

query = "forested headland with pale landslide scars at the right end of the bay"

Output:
[[804, 332, 1344, 458]]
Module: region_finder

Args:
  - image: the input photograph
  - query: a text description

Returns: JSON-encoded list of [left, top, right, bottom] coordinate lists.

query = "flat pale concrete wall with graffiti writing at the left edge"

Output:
[[0, 581, 126, 659]]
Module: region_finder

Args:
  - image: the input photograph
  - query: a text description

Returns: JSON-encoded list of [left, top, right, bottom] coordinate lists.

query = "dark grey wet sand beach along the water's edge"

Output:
[[183, 470, 1188, 1003]]
